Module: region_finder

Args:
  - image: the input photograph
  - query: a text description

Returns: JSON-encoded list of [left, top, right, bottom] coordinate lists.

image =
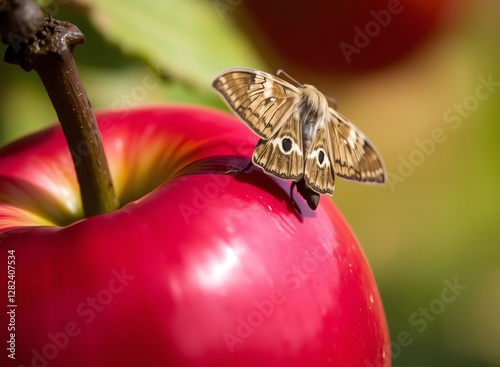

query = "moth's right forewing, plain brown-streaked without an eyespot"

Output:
[[328, 108, 386, 184]]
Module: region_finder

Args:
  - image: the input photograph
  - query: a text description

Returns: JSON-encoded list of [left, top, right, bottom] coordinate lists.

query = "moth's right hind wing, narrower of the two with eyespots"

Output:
[[304, 120, 335, 195]]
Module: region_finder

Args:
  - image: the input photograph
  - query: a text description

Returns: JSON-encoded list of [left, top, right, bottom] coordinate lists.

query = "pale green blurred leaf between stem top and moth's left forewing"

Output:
[[80, 0, 263, 89]]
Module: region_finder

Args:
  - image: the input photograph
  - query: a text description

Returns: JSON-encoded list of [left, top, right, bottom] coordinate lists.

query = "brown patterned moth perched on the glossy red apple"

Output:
[[212, 68, 386, 210]]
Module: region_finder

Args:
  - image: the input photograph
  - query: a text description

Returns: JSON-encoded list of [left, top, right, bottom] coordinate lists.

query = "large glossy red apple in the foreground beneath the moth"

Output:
[[0, 106, 391, 367]]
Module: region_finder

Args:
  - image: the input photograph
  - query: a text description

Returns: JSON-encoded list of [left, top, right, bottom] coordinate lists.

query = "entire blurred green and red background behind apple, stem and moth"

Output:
[[0, 0, 500, 367]]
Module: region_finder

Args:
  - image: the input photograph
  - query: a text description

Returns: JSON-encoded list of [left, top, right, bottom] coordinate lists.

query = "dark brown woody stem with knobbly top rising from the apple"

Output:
[[0, 0, 119, 217]]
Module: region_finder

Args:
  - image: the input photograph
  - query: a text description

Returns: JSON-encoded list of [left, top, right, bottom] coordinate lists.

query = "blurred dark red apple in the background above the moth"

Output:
[[236, 0, 465, 73]]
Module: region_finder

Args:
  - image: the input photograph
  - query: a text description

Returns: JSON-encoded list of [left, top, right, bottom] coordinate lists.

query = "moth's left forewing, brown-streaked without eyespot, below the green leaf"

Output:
[[212, 68, 300, 139]]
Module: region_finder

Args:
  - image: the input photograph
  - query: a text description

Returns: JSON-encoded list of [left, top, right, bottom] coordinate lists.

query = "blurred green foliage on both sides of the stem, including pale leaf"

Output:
[[0, 0, 263, 146]]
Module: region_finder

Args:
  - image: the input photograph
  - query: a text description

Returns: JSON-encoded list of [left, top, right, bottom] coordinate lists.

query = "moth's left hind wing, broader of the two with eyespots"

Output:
[[252, 112, 304, 180]]
